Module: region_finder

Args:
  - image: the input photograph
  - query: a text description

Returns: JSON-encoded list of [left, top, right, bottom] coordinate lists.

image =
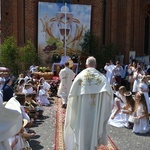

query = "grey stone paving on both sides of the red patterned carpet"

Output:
[[30, 98, 150, 150]]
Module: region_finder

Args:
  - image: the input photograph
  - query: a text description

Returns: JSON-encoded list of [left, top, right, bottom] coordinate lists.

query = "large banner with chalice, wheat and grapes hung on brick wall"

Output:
[[38, 2, 91, 63]]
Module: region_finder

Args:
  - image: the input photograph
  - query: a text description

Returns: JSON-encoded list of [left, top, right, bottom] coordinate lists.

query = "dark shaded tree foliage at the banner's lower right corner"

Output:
[[80, 31, 118, 67]]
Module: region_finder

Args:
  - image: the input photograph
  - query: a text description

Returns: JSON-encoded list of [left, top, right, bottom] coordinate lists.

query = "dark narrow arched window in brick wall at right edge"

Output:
[[144, 10, 150, 55]]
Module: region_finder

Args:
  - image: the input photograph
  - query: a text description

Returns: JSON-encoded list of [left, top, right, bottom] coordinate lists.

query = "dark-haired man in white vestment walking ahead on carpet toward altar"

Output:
[[57, 62, 75, 108]]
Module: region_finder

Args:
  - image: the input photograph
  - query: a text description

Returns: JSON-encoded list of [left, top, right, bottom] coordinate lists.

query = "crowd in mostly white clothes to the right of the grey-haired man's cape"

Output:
[[104, 60, 150, 134]]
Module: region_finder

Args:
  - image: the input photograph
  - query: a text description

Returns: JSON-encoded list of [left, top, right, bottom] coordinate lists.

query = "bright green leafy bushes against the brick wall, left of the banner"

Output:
[[0, 36, 38, 75]]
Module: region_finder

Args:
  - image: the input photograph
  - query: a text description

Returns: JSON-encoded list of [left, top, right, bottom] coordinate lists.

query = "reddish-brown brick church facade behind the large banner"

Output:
[[1, 0, 150, 63]]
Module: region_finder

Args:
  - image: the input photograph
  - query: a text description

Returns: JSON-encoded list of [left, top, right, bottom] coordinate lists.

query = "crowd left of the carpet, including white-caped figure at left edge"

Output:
[[0, 67, 57, 150]]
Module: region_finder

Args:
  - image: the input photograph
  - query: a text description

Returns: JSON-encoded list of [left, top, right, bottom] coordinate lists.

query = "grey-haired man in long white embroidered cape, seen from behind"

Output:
[[64, 57, 113, 150]]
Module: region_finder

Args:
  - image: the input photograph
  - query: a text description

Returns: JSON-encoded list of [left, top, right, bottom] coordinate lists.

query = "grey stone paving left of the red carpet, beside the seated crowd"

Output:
[[30, 105, 56, 150]]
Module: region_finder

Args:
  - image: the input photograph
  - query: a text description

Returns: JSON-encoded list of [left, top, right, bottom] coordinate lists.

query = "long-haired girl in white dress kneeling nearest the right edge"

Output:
[[133, 92, 149, 134]]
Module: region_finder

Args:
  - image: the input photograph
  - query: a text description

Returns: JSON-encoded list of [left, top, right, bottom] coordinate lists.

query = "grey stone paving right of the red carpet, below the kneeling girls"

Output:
[[109, 125, 150, 150]]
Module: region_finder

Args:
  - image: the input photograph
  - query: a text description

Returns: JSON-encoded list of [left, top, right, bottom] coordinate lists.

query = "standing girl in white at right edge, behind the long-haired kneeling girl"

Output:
[[139, 75, 150, 114]]
